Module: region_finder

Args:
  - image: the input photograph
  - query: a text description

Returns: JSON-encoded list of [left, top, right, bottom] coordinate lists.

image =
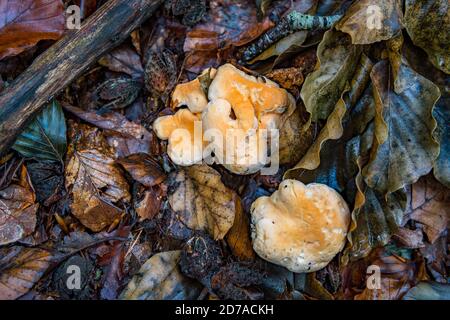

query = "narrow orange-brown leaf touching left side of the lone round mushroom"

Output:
[[226, 201, 255, 260]]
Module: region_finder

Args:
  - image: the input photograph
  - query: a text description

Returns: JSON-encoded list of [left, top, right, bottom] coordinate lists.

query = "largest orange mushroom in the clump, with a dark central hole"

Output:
[[202, 64, 295, 174]]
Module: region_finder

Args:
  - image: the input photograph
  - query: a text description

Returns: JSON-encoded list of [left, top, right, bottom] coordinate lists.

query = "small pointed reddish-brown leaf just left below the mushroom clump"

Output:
[[117, 153, 166, 187]]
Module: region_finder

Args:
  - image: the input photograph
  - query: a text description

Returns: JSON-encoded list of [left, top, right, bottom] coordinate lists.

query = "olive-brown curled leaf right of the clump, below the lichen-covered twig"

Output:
[[301, 30, 361, 121]]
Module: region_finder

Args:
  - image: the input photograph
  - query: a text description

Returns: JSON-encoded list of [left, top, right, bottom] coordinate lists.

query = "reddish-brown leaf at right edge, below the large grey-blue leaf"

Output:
[[407, 175, 450, 243]]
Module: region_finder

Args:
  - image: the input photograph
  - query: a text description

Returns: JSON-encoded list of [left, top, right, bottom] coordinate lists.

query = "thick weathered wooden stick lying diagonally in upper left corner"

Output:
[[0, 0, 162, 156]]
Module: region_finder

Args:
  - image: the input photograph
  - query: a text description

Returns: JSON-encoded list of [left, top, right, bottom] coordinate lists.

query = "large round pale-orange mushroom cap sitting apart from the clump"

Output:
[[251, 179, 350, 272]]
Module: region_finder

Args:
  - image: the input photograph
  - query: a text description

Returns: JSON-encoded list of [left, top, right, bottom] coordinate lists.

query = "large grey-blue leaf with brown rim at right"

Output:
[[363, 60, 440, 193]]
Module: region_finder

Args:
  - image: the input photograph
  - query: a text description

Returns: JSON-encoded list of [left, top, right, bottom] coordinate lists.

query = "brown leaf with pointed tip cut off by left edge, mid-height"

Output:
[[0, 165, 39, 245]]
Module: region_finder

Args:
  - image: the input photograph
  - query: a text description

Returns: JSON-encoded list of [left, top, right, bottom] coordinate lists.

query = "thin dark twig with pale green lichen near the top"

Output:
[[241, 11, 342, 62]]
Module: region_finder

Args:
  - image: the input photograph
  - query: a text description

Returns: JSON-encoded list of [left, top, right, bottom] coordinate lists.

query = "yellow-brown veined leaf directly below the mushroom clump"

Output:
[[168, 165, 239, 240]]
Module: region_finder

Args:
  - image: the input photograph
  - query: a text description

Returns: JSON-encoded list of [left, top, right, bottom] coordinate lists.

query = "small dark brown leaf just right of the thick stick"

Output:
[[98, 45, 144, 79]]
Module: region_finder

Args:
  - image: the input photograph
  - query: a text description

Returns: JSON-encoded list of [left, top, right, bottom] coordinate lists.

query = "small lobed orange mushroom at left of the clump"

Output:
[[153, 109, 203, 166]]
